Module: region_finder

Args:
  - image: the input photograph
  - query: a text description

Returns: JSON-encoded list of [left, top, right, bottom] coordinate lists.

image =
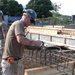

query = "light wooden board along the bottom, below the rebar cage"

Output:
[[24, 61, 75, 75]]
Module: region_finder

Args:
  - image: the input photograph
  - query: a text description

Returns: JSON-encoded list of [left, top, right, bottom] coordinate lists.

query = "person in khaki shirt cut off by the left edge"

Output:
[[0, 10, 7, 56]]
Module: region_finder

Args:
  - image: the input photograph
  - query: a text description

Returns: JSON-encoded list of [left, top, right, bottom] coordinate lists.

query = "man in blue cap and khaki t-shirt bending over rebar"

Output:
[[1, 9, 42, 75]]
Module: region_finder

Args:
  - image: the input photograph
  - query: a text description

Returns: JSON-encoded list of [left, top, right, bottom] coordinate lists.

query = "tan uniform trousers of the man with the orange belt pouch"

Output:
[[1, 59, 24, 75]]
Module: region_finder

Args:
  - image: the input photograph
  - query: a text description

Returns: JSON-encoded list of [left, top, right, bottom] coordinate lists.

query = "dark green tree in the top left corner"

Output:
[[0, 0, 23, 16]]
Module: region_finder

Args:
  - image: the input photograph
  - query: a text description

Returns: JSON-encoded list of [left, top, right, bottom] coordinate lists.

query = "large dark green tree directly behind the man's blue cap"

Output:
[[26, 0, 53, 18]]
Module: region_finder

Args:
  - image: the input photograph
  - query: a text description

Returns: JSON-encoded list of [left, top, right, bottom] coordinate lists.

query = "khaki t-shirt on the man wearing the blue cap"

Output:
[[2, 21, 25, 58]]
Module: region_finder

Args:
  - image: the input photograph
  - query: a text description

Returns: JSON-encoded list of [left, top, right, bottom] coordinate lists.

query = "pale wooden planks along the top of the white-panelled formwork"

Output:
[[27, 26, 75, 36]]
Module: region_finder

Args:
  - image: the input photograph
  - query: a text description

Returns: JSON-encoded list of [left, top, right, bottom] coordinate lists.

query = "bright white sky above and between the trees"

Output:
[[16, 0, 75, 16]]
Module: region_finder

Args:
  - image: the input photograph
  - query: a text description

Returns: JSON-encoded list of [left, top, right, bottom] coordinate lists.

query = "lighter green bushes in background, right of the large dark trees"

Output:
[[48, 13, 72, 25]]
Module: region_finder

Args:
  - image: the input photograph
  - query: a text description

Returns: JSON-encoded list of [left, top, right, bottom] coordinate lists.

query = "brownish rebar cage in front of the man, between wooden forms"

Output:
[[25, 46, 75, 75]]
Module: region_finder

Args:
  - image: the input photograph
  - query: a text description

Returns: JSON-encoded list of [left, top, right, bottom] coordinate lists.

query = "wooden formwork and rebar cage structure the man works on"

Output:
[[18, 26, 75, 75]]
